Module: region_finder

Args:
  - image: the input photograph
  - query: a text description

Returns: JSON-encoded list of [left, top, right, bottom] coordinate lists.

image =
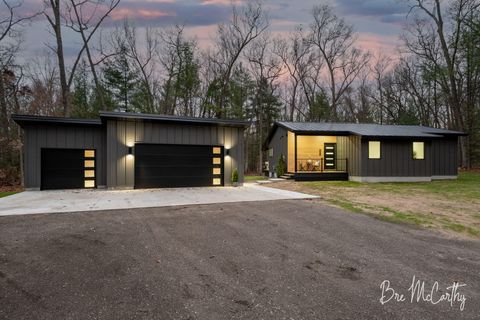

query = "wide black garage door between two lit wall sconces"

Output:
[[135, 144, 223, 188]]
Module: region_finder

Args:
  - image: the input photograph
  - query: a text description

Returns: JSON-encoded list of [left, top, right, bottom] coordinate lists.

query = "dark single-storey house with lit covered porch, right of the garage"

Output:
[[266, 122, 464, 182]]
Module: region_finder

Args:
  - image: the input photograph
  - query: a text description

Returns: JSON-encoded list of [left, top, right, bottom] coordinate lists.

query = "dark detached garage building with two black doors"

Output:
[[12, 112, 249, 190]]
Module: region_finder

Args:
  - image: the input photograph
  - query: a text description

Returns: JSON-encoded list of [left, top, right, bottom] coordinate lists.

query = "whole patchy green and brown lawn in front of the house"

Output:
[[272, 172, 480, 238]]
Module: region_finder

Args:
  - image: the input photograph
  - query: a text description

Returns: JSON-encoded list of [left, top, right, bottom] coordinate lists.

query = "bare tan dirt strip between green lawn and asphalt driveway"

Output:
[[269, 181, 480, 238]]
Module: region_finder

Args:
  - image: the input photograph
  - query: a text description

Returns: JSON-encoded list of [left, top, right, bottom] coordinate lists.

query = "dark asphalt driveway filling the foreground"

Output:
[[0, 200, 480, 319]]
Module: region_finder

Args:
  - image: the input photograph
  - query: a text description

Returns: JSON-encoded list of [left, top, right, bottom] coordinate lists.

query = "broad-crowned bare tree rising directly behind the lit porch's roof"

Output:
[[310, 5, 369, 120]]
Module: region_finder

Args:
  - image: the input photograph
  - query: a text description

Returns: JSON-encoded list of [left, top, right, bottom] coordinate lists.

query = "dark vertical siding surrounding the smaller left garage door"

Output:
[[24, 124, 106, 189]]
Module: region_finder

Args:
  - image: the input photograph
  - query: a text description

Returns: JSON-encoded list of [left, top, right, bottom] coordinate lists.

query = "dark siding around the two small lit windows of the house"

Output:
[[361, 138, 432, 177]]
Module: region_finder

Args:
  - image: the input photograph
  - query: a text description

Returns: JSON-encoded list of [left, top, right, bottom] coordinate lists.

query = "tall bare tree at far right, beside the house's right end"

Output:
[[405, 0, 480, 167]]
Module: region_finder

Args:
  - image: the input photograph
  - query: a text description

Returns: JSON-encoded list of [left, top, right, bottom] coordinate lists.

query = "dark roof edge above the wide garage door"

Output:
[[100, 111, 250, 127]]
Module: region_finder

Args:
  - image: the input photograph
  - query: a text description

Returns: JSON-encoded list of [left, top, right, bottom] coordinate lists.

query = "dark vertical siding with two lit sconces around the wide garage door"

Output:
[[107, 119, 244, 188]]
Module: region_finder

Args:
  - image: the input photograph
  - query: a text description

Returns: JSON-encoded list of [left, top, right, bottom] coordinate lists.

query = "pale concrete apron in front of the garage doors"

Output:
[[0, 184, 316, 216]]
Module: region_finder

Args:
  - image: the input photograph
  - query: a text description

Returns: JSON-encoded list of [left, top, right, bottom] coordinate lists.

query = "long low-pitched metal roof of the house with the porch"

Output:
[[272, 122, 465, 138]]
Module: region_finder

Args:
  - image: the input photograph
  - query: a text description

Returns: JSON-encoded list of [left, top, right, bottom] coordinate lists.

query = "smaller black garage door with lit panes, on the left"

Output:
[[41, 149, 96, 190]]
